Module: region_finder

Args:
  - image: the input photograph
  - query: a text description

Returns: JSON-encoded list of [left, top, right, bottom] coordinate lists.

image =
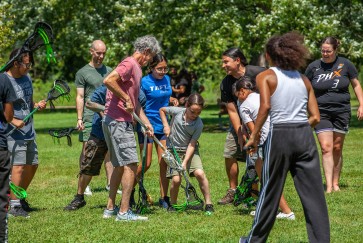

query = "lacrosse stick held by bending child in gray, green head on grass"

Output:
[[168, 138, 204, 210]]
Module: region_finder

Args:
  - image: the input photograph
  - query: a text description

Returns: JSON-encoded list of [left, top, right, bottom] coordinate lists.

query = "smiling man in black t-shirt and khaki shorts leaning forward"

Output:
[[218, 47, 265, 205]]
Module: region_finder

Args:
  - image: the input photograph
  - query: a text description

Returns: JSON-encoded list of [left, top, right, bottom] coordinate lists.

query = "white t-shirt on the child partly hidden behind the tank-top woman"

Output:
[[239, 93, 270, 145]]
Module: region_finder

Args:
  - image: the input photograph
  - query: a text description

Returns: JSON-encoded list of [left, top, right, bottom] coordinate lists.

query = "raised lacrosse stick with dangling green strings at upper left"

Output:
[[0, 22, 56, 72]]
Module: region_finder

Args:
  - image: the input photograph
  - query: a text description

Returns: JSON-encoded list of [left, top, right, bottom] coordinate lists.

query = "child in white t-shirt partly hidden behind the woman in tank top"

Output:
[[235, 76, 295, 220]]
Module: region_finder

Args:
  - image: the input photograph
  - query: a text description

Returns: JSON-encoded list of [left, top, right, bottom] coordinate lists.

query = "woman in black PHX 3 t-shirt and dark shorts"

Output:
[[305, 37, 363, 193]]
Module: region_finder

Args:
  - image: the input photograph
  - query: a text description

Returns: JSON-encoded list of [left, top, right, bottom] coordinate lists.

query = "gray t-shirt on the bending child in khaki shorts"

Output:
[[166, 106, 203, 150]]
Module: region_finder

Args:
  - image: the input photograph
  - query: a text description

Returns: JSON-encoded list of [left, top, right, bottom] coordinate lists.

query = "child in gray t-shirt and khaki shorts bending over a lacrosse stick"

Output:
[[160, 93, 214, 213]]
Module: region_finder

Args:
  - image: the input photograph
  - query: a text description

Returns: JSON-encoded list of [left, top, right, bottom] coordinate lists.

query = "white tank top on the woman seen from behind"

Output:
[[270, 67, 308, 124]]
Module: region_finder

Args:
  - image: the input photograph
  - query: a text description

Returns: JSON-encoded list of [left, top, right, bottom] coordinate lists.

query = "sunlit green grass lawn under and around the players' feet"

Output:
[[9, 106, 363, 242]]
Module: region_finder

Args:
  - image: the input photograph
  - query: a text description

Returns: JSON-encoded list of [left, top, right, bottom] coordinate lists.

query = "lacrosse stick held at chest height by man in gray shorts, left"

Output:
[[6, 79, 71, 136]]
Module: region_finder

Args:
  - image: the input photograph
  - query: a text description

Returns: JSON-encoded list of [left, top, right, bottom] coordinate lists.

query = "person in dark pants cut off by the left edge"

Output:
[[0, 73, 16, 242]]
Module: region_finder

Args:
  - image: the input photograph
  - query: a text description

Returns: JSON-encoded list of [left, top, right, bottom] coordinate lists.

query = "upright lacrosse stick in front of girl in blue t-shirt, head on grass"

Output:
[[136, 128, 150, 214]]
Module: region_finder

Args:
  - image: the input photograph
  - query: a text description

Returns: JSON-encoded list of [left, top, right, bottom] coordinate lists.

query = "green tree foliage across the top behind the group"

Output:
[[0, 0, 363, 98]]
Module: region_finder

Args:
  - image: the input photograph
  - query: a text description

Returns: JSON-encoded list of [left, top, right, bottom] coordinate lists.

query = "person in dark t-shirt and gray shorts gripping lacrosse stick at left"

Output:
[[5, 49, 46, 218]]
